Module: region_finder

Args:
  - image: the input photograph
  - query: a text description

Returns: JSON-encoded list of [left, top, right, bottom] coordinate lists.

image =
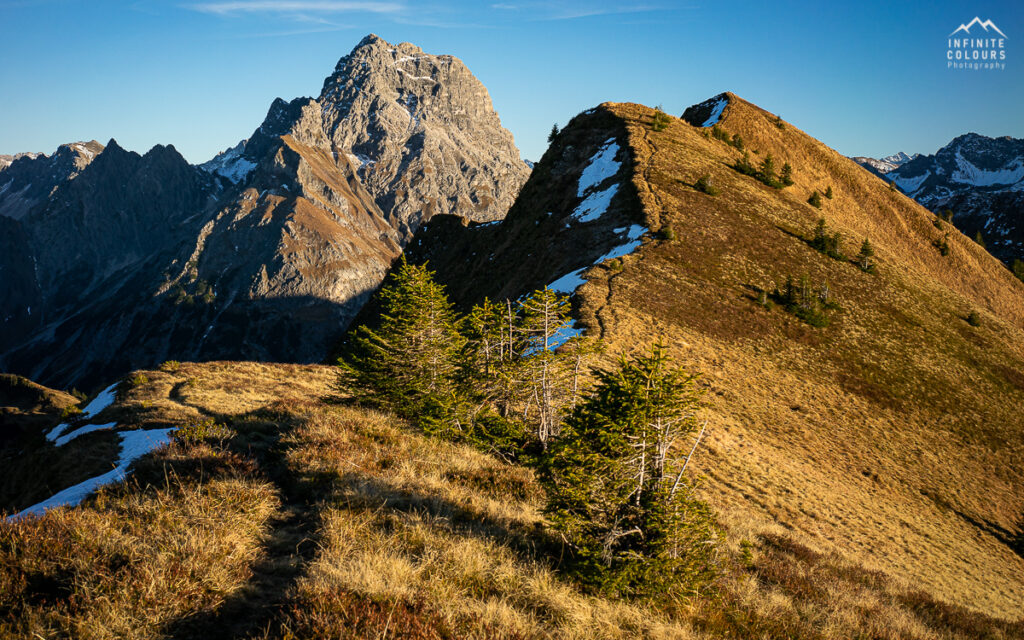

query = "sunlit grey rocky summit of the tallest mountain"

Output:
[[317, 35, 529, 237]]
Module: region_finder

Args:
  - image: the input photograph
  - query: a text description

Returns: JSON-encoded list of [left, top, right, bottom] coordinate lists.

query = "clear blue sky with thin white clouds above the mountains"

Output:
[[0, 0, 1024, 163]]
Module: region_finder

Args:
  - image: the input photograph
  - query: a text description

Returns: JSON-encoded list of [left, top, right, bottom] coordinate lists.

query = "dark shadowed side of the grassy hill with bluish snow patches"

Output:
[[407, 104, 648, 307]]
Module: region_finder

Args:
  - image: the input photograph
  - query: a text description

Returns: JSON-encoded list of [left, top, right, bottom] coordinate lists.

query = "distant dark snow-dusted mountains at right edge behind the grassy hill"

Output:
[[853, 133, 1024, 264]]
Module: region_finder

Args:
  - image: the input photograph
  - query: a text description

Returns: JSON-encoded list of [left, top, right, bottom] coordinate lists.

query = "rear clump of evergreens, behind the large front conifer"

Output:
[[339, 259, 600, 457]]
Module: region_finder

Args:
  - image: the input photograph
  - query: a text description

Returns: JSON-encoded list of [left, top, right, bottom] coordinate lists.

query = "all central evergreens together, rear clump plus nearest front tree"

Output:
[[339, 259, 722, 600]]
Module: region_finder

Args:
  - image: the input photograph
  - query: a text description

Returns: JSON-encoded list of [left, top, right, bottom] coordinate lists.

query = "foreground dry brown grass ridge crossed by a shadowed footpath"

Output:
[[0, 362, 1024, 640]]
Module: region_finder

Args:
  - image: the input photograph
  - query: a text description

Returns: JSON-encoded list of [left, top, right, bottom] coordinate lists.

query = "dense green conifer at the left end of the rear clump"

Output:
[[338, 256, 464, 418]]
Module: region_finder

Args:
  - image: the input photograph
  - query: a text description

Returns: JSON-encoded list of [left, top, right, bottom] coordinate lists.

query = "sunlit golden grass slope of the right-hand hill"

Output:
[[578, 99, 1024, 618]]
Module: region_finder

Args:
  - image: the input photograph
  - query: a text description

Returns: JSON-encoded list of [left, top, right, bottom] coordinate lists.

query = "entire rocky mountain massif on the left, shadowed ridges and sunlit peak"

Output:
[[0, 36, 529, 388]]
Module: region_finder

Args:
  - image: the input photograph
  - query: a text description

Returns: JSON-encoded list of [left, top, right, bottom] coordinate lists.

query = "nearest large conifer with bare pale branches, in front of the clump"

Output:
[[542, 344, 721, 597]]
